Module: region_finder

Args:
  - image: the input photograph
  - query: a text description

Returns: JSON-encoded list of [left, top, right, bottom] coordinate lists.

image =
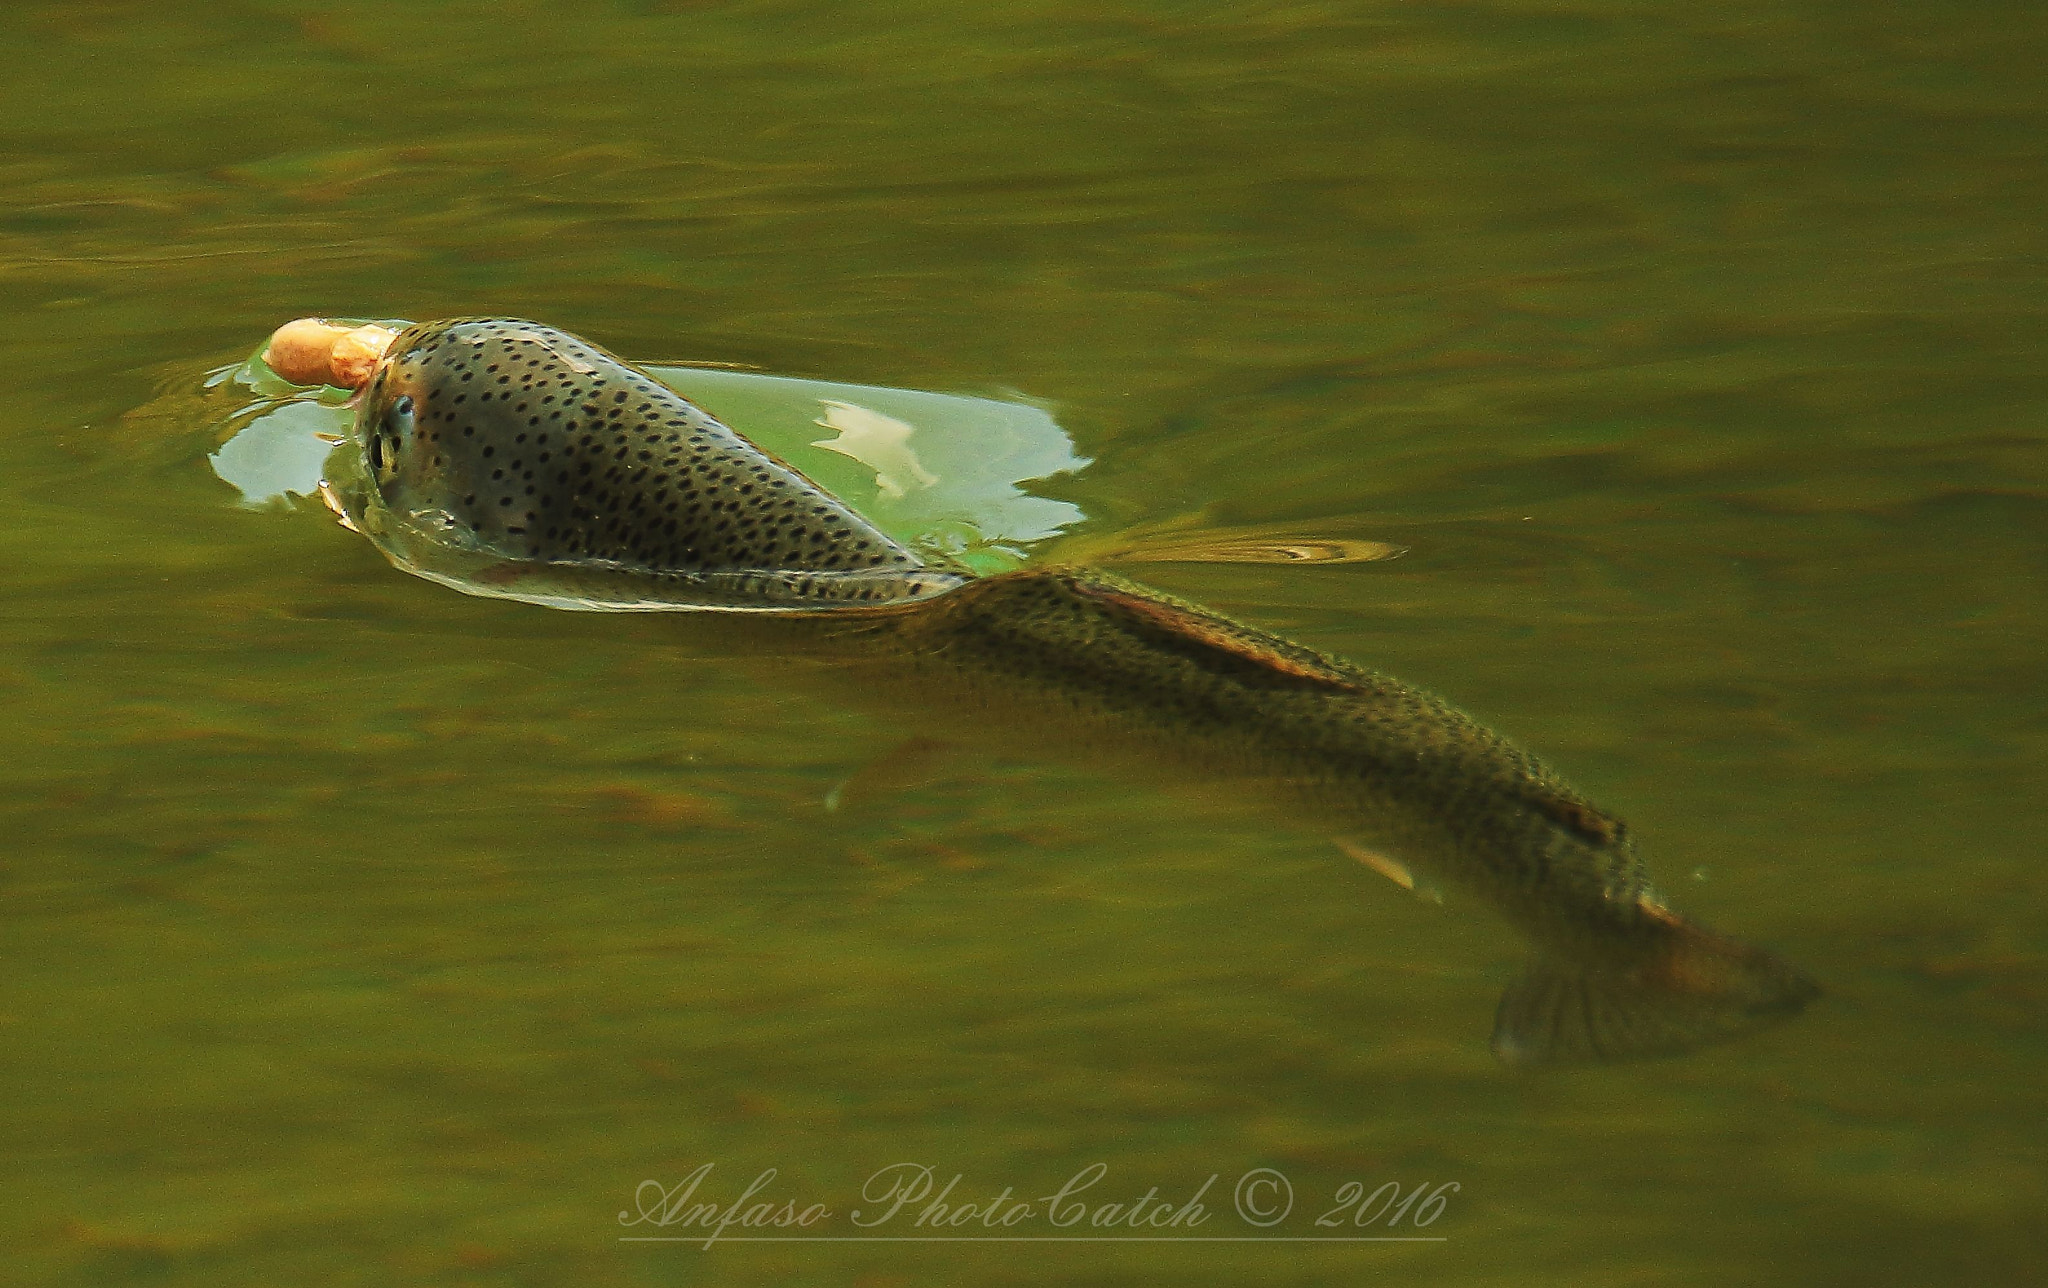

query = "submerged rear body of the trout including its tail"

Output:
[[839, 567, 1819, 1063]]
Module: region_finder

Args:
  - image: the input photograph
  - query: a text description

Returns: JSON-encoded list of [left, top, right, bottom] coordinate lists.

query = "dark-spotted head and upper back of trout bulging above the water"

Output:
[[337, 317, 963, 608]]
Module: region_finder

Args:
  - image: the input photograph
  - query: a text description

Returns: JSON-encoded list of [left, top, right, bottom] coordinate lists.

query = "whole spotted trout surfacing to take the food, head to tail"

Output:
[[338, 319, 1821, 1067]]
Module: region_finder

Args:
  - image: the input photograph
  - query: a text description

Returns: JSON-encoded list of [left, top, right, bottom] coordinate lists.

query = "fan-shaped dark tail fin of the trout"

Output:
[[1493, 917, 1821, 1065]]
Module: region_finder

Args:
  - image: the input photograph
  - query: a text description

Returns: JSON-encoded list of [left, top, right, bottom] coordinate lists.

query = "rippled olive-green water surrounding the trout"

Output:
[[0, 0, 2048, 1288]]
